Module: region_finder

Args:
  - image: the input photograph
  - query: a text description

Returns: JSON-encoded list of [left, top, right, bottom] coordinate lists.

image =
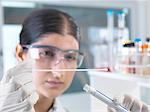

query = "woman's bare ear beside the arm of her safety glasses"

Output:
[[16, 44, 26, 61]]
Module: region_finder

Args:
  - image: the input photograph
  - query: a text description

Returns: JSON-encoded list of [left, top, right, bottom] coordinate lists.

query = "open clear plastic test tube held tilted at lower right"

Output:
[[83, 84, 129, 112]]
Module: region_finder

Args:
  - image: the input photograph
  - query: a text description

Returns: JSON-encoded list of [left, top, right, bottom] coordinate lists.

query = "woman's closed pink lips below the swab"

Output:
[[46, 81, 64, 88]]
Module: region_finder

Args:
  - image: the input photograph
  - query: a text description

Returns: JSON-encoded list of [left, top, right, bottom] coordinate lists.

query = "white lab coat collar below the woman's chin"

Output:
[[48, 99, 68, 112]]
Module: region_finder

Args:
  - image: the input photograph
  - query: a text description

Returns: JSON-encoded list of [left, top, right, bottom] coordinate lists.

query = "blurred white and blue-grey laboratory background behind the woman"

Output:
[[0, 0, 150, 112]]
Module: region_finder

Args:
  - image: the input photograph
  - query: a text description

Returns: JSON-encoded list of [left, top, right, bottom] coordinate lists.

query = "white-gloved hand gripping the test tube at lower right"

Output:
[[108, 95, 150, 112]]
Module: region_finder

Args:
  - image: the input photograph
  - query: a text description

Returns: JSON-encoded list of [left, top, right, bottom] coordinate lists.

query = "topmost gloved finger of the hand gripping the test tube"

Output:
[[122, 95, 134, 110]]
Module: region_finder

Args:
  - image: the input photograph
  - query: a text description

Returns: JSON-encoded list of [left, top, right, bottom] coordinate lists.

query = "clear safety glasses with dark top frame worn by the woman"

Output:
[[23, 45, 84, 70]]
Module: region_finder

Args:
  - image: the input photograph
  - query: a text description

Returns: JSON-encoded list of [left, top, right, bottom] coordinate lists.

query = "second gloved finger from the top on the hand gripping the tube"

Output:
[[130, 99, 143, 112]]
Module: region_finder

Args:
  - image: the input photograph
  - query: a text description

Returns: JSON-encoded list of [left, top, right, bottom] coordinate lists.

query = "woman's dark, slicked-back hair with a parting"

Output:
[[20, 9, 80, 45]]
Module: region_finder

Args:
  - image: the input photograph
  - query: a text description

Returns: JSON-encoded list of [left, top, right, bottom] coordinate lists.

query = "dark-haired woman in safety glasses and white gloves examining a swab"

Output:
[[0, 9, 150, 112]]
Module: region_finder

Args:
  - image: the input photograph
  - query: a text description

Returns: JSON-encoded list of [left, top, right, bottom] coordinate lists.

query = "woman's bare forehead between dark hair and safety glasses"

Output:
[[33, 34, 79, 50]]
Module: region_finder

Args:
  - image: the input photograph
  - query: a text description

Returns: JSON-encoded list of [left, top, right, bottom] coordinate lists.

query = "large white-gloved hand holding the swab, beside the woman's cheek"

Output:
[[0, 61, 38, 112]]
